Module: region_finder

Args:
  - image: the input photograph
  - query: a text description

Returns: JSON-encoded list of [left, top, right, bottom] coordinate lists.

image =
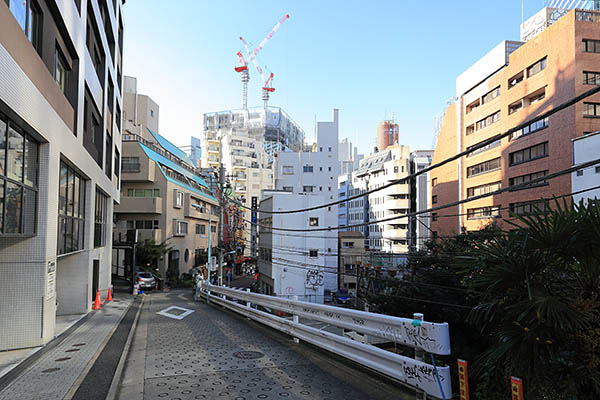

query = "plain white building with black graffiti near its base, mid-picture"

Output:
[[259, 109, 339, 296]]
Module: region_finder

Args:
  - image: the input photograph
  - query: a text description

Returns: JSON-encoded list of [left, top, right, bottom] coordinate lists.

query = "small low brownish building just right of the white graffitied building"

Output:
[[337, 232, 369, 297]]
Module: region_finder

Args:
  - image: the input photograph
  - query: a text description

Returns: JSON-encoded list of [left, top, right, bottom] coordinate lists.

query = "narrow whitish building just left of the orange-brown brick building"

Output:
[[409, 150, 433, 250]]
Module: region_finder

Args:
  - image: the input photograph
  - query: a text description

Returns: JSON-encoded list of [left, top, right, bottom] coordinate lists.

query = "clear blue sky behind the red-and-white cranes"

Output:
[[124, 0, 544, 153]]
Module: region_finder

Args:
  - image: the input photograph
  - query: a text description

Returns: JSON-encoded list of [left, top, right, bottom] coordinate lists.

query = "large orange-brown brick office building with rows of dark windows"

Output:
[[431, 9, 600, 235]]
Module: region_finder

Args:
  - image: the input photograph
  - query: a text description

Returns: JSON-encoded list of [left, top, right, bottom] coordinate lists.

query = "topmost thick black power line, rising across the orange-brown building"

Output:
[[227, 86, 600, 214]]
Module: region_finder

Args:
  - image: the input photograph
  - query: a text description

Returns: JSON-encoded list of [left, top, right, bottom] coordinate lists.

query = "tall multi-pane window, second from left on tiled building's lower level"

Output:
[[58, 162, 85, 255]]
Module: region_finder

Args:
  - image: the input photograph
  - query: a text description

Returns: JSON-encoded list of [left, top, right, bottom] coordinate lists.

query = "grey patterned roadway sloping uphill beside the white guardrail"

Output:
[[119, 291, 415, 400]]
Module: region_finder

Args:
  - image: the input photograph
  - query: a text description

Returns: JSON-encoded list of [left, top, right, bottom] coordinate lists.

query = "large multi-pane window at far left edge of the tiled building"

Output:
[[0, 114, 38, 235]]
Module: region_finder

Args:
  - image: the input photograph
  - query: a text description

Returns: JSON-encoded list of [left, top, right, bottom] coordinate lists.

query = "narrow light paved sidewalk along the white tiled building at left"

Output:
[[0, 297, 133, 400]]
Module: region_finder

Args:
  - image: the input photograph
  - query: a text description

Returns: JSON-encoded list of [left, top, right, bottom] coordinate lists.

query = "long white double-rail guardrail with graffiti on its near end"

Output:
[[196, 281, 452, 399]]
